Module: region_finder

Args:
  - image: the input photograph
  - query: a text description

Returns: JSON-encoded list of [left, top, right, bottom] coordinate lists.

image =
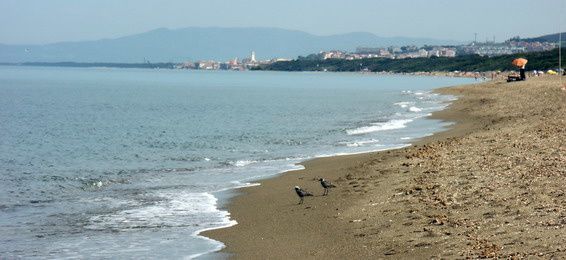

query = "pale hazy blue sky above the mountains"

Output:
[[0, 0, 566, 44]]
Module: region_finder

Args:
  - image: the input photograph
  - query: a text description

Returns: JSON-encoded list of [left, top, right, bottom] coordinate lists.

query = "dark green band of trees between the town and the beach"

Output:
[[254, 48, 566, 73]]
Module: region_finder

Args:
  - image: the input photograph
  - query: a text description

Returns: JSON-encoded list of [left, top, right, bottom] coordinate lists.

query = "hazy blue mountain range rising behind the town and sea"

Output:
[[0, 27, 457, 63]]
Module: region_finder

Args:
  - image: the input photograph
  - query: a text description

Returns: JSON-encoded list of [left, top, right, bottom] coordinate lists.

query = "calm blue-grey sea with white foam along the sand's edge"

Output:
[[0, 66, 470, 258]]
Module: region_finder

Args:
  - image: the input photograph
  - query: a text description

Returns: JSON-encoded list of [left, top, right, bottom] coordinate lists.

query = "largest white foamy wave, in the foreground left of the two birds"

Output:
[[85, 190, 243, 259]]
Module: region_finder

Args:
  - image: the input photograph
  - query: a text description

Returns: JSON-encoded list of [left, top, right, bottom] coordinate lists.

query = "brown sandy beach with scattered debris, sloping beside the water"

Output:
[[203, 76, 566, 259]]
